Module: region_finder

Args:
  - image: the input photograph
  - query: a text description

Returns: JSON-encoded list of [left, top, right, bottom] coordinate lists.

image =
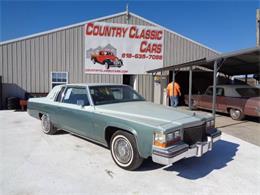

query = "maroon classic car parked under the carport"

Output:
[[185, 85, 260, 120]]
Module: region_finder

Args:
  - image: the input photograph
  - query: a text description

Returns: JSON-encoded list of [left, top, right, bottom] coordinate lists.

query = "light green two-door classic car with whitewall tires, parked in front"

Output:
[[28, 84, 221, 170]]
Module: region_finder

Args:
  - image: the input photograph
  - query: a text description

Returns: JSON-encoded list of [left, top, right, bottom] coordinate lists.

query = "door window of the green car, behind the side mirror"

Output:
[[62, 87, 89, 106]]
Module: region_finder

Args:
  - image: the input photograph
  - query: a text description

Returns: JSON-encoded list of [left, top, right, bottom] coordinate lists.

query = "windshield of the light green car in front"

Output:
[[89, 85, 145, 105]]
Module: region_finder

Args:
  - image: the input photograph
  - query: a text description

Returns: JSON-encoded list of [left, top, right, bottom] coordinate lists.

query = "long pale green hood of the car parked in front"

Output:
[[95, 101, 211, 130]]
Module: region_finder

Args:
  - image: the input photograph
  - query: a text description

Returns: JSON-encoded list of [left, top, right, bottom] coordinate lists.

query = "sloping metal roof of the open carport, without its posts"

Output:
[[148, 47, 260, 76]]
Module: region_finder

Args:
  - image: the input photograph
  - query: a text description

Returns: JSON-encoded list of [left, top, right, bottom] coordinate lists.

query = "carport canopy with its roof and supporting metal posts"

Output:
[[147, 46, 260, 117]]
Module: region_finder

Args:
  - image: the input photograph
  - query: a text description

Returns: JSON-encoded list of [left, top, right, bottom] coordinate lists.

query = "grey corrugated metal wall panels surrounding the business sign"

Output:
[[0, 12, 218, 100]]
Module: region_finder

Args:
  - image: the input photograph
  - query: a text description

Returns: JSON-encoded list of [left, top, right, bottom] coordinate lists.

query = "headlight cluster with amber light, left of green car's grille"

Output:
[[154, 130, 181, 148]]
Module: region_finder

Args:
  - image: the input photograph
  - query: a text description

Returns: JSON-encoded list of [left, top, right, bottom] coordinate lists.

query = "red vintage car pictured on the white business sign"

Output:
[[91, 51, 123, 69]]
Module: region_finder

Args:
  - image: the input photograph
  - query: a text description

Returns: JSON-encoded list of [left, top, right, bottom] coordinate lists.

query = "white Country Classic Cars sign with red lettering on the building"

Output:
[[84, 22, 163, 74]]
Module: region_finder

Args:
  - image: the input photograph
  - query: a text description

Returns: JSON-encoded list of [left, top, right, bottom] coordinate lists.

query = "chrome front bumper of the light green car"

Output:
[[152, 130, 221, 165]]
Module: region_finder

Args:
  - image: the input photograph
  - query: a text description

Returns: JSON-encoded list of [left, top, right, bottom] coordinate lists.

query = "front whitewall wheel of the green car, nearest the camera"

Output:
[[110, 131, 143, 171]]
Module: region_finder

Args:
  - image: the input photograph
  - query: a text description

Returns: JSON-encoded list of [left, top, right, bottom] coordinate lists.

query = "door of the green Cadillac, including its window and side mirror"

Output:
[[58, 86, 96, 138]]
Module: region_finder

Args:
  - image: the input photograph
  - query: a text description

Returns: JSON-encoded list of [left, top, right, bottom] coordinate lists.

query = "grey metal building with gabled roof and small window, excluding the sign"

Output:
[[0, 11, 218, 108]]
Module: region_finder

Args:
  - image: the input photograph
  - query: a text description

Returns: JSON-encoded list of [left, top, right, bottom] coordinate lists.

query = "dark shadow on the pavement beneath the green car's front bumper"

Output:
[[137, 140, 239, 180]]
